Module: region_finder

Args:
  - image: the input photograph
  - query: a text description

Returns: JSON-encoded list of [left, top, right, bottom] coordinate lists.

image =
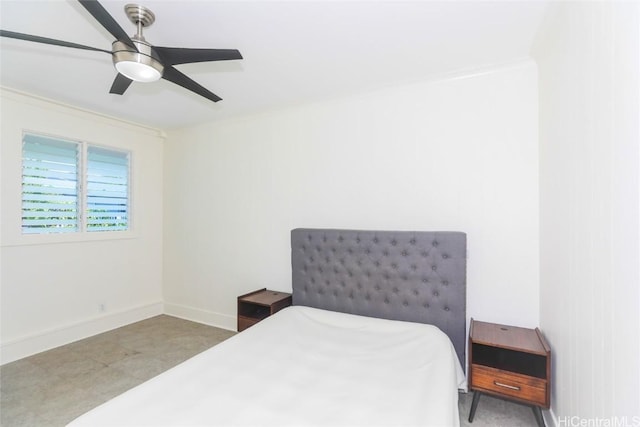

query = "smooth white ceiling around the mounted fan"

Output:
[[0, 0, 547, 129]]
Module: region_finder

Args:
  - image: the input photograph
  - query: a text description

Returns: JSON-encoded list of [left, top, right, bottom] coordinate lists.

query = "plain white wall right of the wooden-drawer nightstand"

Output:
[[534, 2, 640, 425]]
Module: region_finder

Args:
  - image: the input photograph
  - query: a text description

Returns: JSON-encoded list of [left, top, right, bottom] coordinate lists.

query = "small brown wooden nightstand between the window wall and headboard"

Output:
[[238, 288, 291, 332]]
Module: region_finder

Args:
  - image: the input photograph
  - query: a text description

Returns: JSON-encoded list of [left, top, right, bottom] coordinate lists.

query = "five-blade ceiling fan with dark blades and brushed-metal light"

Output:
[[0, 0, 242, 102]]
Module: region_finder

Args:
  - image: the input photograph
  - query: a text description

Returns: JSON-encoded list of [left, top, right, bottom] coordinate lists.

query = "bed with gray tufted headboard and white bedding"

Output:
[[70, 229, 466, 427]]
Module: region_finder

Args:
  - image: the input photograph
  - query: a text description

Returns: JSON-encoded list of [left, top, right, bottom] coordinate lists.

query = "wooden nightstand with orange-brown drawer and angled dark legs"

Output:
[[468, 319, 551, 427]]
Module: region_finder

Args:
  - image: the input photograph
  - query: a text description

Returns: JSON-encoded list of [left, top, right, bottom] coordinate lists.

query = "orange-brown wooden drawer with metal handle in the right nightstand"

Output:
[[471, 364, 547, 406]]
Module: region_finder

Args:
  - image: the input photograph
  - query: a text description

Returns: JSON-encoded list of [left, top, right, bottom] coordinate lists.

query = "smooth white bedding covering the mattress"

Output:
[[70, 306, 464, 427]]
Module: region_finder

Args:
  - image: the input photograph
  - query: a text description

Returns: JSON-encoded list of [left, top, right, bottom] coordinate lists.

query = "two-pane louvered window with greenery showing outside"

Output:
[[22, 134, 130, 234]]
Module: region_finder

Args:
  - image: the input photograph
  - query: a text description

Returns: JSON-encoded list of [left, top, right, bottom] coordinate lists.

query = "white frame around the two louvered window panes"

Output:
[[18, 129, 137, 246]]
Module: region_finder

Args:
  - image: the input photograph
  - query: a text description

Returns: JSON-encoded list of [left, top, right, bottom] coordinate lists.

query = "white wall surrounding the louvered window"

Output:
[[0, 89, 163, 363]]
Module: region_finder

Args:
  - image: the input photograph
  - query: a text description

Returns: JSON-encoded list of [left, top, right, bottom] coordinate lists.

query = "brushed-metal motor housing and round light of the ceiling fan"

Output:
[[113, 40, 164, 83]]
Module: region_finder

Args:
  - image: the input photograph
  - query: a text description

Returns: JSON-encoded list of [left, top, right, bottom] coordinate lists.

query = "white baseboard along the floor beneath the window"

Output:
[[0, 302, 163, 365]]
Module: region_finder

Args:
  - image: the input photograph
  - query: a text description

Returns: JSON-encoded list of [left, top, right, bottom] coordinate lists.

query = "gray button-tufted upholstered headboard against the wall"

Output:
[[291, 228, 467, 369]]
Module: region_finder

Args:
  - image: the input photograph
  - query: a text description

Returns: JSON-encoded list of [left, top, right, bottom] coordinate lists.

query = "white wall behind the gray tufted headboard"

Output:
[[164, 61, 539, 328]]
